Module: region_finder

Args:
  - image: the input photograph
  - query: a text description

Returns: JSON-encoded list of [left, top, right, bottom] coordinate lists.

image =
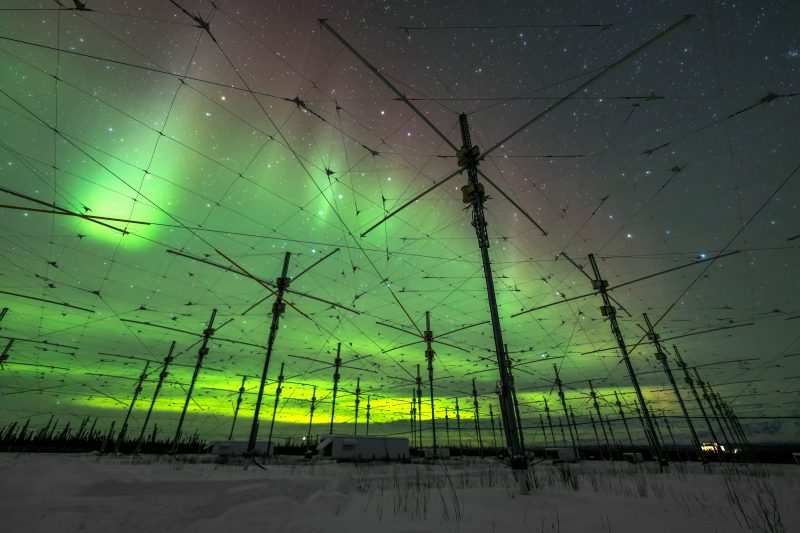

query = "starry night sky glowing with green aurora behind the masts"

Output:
[[0, 0, 800, 444]]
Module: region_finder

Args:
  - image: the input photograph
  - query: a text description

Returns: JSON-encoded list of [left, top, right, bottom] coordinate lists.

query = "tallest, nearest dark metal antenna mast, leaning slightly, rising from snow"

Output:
[[456, 114, 527, 470]]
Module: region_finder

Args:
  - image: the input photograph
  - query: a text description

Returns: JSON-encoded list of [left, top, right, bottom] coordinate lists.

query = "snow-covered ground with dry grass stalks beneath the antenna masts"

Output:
[[0, 454, 800, 533]]
